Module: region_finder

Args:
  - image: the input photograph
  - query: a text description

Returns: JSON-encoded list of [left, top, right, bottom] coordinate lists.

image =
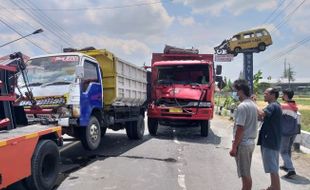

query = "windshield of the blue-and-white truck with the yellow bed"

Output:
[[18, 56, 79, 86]]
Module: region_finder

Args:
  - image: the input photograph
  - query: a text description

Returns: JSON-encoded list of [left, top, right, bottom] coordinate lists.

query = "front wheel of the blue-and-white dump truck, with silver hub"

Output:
[[81, 116, 101, 150]]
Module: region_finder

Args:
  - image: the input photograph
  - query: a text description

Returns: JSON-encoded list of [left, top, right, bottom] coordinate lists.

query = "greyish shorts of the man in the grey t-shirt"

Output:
[[236, 144, 255, 177]]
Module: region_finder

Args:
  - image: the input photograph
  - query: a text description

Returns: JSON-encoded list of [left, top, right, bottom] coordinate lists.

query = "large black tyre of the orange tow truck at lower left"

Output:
[[24, 140, 60, 190]]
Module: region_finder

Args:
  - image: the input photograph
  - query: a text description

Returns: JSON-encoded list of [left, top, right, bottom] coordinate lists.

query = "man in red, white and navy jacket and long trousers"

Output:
[[280, 89, 300, 178]]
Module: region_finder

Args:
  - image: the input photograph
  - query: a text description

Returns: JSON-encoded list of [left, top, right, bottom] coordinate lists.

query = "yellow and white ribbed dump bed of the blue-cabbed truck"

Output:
[[81, 50, 147, 106]]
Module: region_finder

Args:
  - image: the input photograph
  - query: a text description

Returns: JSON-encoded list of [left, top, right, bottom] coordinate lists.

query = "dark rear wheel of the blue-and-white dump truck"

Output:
[[126, 115, 145, 139]]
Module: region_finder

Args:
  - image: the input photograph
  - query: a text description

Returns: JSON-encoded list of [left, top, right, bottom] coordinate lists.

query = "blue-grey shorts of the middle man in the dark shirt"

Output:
[[261, 146, 279, 173]]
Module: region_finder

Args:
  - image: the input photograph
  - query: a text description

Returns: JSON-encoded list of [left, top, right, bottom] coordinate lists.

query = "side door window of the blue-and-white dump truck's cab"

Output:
[[82, 60, 99, 92]]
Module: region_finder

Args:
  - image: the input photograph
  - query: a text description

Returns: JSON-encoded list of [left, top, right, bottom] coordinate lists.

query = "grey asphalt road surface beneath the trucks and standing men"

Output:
[[7, 116, 310, 190]]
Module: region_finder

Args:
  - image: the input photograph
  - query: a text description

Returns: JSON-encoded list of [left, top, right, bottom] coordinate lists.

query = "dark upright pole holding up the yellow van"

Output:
[[243, 52, 254, 94]]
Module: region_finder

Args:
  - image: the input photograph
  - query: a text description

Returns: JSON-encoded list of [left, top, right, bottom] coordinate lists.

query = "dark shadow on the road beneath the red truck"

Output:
[[153, 125, 221, 145]]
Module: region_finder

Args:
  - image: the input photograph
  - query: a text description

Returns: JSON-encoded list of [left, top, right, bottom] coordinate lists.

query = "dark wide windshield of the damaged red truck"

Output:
[[157, 64, 210, 85]]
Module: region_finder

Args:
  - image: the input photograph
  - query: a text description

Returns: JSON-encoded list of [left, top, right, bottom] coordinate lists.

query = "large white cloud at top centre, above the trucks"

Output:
[[44, 0, 174, 37]]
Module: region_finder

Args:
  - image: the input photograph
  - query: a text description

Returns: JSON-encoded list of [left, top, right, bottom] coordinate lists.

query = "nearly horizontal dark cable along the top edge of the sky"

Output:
[[0, 0, 173, 11]]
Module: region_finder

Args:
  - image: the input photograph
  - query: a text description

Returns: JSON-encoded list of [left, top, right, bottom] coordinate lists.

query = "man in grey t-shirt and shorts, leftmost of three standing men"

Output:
[[230, 79, 257, 190]]
